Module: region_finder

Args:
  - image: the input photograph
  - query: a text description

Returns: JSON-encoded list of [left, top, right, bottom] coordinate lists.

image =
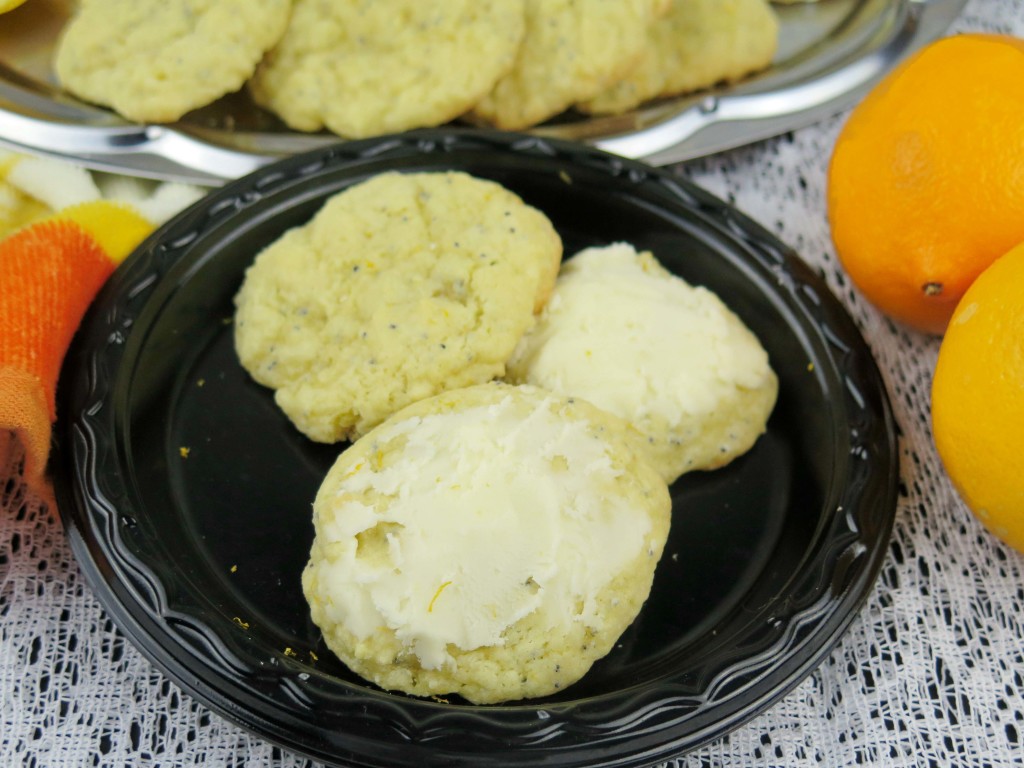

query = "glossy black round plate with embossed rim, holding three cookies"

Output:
[[54, 130, 898, 767]]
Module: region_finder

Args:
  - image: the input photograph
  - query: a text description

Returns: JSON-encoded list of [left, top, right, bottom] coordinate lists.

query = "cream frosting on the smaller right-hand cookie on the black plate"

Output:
[[510, 243, 772, 424]]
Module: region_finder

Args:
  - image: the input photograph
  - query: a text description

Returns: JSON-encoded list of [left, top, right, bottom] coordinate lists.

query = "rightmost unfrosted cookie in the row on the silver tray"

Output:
[[578, 0, 778, 114]]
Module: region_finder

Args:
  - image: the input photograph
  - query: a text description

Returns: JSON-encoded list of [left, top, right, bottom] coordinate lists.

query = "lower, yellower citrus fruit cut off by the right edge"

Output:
[[932, 244, 1024, 552]]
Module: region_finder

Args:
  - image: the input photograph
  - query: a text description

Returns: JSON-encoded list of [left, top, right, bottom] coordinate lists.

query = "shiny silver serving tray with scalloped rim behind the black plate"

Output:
[[0, 0, 966, 184]]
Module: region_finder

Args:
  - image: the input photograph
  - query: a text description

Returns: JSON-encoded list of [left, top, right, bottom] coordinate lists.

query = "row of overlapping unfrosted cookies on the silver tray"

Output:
[[55, 0, 778, 138]]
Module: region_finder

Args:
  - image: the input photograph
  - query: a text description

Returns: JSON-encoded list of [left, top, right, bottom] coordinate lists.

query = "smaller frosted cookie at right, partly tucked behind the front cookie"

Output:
[[507, 244, 778, 482]]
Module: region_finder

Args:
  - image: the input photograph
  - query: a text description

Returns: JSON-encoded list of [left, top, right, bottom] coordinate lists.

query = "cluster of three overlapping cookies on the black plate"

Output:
[[234, 172, 778, 702]]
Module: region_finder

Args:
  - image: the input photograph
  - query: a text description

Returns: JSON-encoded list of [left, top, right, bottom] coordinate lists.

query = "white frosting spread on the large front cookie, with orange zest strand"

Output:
[[317, 398, 650, 669]]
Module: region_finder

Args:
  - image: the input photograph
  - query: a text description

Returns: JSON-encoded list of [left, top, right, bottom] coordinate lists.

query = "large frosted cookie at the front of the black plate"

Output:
[[302, 384, 671, 703]]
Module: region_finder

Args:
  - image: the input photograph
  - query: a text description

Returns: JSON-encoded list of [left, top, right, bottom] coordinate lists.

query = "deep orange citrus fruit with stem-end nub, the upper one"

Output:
[[827, 34, 1024, 334]]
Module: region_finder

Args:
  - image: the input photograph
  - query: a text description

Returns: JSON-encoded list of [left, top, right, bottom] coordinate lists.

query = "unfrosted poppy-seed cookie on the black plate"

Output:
[[234, 173, 562, 442]]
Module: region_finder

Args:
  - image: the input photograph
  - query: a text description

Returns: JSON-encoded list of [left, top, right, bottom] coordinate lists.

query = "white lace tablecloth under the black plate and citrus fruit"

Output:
[[0, 0, 1024, 768]]
